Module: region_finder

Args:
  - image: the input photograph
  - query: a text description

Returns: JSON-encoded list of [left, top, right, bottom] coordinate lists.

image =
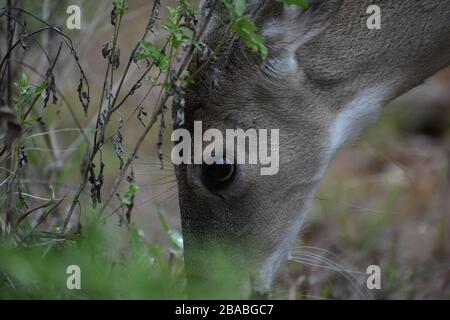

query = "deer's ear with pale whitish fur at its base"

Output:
[[261, 0, 343, 75]]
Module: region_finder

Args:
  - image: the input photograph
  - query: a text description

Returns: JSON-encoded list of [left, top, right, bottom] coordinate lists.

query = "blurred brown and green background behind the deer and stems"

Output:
[[0, 0, 450, 299]]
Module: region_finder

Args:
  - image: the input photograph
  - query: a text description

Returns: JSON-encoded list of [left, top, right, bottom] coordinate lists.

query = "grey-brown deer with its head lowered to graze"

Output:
[[175, 0, 450, 298]]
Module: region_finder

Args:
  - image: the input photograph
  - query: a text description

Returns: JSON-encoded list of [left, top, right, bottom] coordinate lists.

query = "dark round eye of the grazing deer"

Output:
[[202, 159, 236, 190]]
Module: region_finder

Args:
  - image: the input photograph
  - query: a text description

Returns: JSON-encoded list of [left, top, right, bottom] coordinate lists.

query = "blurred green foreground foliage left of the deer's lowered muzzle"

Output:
[[0, 214, 185, 299]]
